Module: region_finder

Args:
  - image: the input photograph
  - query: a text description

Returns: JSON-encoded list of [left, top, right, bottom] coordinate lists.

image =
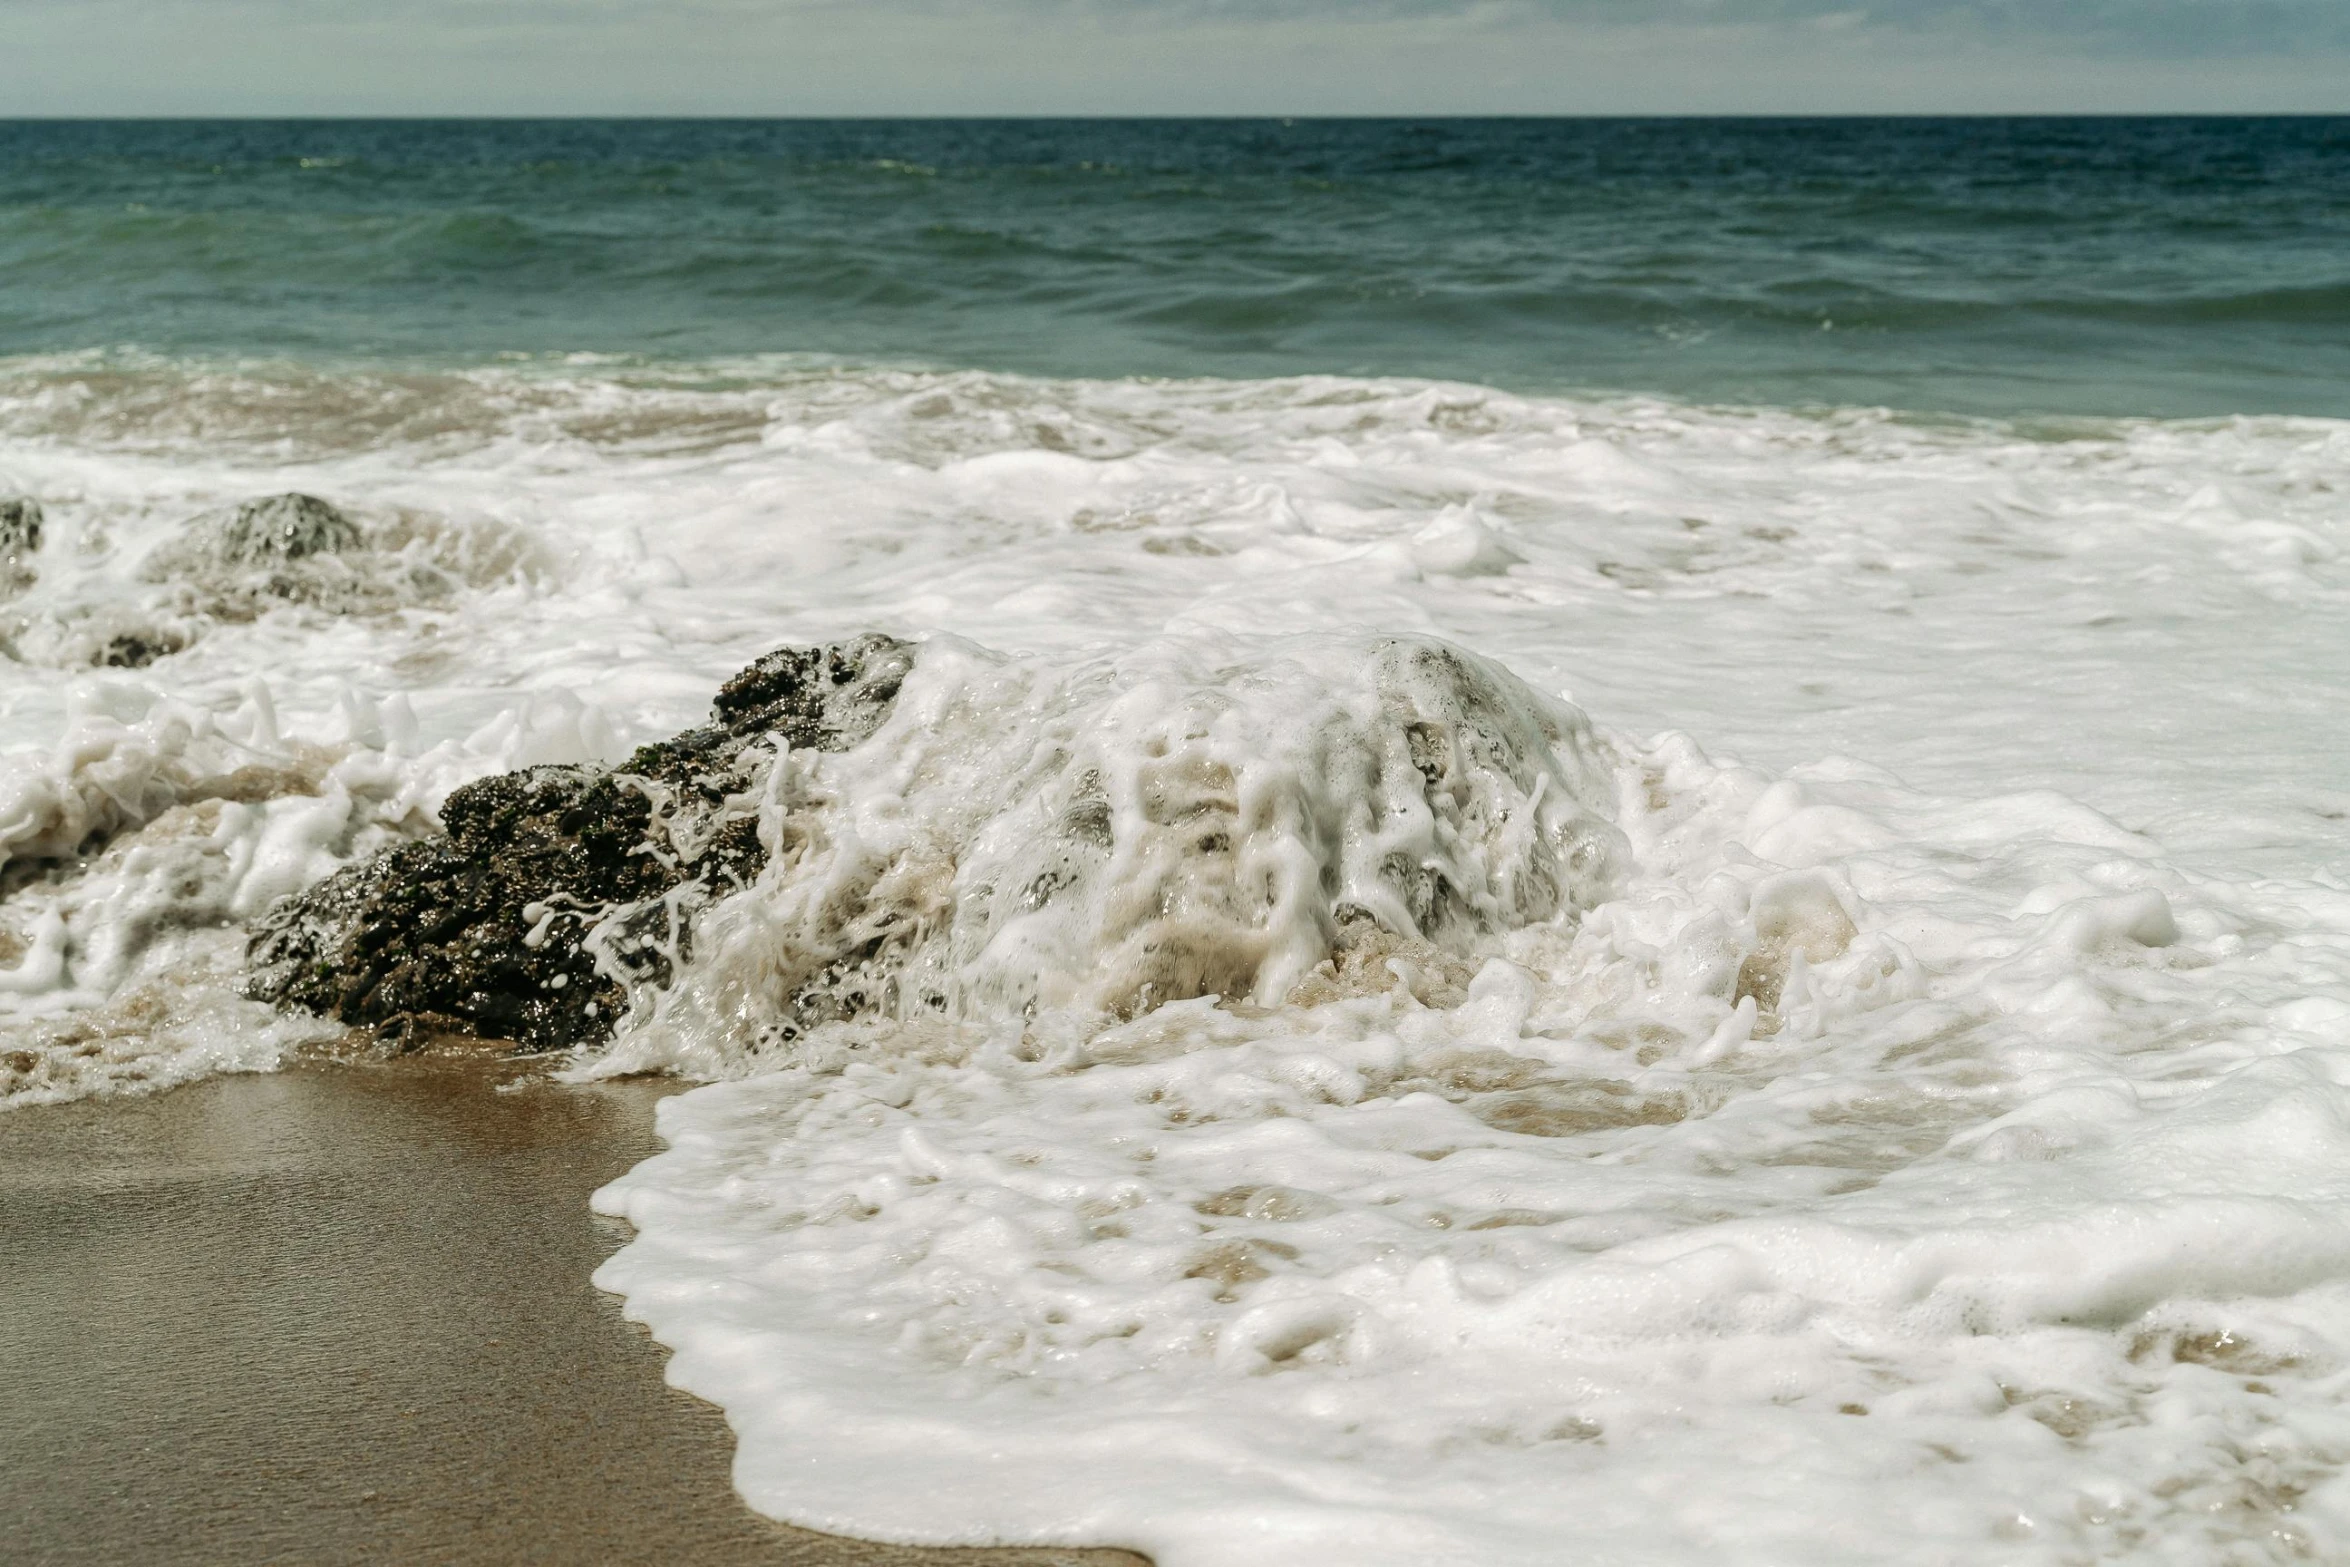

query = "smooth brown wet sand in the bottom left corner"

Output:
[[0, 1057, 1144, 1567]]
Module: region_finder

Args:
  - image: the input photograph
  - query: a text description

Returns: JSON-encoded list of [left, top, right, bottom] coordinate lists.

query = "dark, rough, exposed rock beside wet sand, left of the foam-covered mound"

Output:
[[249, 634, 912, 1050]]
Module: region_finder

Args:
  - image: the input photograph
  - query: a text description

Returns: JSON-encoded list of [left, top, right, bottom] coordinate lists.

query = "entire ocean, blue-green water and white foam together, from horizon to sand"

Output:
[[0, 120, 2350, 1567]]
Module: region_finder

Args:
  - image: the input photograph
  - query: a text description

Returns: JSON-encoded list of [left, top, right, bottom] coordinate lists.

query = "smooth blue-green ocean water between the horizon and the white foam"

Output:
[[0, 117, 2350, 416]]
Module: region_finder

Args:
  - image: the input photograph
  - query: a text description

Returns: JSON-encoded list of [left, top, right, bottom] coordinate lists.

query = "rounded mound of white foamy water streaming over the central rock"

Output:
[[578, 637, 1622, 1076]]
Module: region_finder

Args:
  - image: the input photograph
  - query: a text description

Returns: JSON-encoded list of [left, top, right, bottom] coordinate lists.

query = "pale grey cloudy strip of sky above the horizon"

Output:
[[0, 0, 2350, 117]]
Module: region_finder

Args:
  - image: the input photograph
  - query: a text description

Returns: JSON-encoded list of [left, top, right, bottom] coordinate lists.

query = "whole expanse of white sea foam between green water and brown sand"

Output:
[[0, 362, 2350, 1567]]
